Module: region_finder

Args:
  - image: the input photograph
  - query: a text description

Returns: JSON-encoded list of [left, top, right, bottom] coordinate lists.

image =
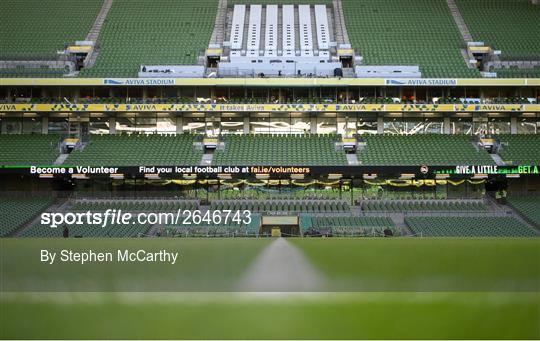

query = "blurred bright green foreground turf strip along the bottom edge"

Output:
[[0, 292, 540, 339]]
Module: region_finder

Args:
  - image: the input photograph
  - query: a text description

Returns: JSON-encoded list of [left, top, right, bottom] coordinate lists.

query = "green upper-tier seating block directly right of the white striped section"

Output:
[[342, 0, 480, 78]]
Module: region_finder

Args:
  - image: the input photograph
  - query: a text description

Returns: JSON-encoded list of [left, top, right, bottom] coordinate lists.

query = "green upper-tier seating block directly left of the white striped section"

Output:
[[80, 0, 218, 77]]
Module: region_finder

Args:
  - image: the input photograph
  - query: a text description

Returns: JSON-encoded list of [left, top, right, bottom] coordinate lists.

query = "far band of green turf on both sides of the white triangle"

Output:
[[0, 238, 540, 292]]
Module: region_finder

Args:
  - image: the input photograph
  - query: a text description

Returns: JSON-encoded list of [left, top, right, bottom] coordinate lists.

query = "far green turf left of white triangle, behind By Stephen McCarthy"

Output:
[[0, 238, 271, 291]]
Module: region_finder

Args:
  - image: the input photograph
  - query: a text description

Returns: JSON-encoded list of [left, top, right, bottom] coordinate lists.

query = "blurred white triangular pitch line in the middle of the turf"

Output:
[[239, 238, 324, 292]]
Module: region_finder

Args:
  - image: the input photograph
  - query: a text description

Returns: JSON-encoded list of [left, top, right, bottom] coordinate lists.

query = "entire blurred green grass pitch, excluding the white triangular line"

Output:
[[0, 238, 540, 339]]
